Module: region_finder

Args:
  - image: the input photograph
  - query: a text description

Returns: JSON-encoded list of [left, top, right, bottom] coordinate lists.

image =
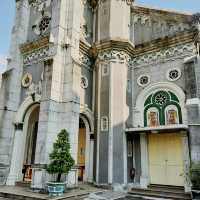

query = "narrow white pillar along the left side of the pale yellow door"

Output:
[[140, 133, 149, 188]]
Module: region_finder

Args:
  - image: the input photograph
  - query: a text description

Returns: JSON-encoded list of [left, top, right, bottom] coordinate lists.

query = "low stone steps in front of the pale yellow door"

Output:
[[129, 185, 192, 200]]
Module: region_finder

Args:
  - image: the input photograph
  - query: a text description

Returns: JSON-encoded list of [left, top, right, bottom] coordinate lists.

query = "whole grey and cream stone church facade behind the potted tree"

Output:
[[0, 0, 200, 191]]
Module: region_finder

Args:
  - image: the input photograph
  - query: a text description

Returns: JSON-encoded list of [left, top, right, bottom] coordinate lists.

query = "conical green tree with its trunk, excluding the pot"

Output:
[[47, 129, 75, 182]]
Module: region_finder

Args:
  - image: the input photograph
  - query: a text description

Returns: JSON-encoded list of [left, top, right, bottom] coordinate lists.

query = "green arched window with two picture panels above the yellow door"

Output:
[[144, 90, 182, 127]]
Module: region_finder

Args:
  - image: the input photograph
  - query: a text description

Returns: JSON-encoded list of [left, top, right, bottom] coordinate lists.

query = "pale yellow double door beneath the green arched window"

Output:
[[149, 133, 184, 186]]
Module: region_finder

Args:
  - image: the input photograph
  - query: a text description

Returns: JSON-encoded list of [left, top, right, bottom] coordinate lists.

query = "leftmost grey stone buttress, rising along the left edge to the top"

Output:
[[0, 0, 30, 184]]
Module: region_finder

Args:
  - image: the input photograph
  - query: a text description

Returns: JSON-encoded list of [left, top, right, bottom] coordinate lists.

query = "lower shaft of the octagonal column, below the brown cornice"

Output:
[[97, 50, 128, 184]]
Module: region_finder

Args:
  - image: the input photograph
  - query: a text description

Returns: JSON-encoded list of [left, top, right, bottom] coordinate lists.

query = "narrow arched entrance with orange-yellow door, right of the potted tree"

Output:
[[77, 115, 94, 182]]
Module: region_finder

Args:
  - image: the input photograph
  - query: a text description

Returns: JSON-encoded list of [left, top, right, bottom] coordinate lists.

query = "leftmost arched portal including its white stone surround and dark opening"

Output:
[[6, 102, 40, 185]]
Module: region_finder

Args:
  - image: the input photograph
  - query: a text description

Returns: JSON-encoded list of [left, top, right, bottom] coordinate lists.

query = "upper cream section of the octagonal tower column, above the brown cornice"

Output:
[[97, 0, 133, 40]]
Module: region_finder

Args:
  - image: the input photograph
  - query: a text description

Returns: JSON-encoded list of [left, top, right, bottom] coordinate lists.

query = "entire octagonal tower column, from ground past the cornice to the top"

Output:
[[95, 0, 133, 184]]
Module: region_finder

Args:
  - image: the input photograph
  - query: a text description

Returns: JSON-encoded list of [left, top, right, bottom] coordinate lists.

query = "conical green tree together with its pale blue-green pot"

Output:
[[47, 129, 75, 196]]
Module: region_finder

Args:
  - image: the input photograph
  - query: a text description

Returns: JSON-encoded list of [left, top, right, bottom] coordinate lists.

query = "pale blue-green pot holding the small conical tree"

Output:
[[47, 182, 65, 196]]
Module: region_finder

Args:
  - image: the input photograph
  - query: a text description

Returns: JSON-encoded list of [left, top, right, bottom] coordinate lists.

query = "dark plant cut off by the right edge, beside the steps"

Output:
[[190, 162, 200, 199]]
